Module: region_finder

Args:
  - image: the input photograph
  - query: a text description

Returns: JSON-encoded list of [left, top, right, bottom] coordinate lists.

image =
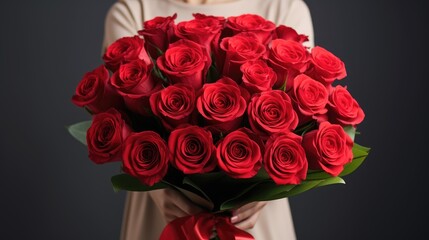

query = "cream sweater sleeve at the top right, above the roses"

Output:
[[285, 0, 314, 47]]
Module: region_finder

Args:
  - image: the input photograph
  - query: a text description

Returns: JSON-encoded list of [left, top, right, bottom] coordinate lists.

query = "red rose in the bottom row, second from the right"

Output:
[[264, 132, 308, 184]]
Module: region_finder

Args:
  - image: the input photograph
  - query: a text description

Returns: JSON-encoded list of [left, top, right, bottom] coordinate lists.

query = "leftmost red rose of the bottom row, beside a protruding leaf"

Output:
[[86, 108, 131, 164]]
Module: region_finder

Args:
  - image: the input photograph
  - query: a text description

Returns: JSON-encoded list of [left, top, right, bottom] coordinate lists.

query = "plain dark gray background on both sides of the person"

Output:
[[0, 0, 429, 240]]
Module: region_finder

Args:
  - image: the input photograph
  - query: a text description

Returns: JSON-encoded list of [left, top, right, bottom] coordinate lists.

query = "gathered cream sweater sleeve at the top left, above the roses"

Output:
[[102, 0, 143, 54]]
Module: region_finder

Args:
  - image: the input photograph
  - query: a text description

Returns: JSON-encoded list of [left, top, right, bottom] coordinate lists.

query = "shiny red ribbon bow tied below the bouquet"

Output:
[[159, 213, 254, 240]]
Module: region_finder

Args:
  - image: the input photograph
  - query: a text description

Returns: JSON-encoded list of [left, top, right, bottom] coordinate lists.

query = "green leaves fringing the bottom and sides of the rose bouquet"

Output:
[[68, 121, 370, 212]]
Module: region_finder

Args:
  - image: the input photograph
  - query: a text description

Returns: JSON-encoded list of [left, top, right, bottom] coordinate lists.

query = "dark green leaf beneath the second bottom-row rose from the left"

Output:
[[111, 174, 169, 192]]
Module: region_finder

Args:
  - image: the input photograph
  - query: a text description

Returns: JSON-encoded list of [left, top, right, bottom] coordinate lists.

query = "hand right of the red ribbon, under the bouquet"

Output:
[[231, 202, 267, 230]]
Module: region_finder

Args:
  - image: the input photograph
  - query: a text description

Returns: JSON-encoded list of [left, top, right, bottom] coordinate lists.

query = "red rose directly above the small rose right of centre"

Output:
[[219, 33, 266, 83]]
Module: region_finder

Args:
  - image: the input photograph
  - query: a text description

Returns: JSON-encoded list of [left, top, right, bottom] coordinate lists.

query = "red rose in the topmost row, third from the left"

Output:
[[226, 14, 276, 45]]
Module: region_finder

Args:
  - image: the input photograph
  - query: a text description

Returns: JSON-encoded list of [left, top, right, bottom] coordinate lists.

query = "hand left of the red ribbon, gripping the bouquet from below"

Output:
[[148, 188, 204, 223]]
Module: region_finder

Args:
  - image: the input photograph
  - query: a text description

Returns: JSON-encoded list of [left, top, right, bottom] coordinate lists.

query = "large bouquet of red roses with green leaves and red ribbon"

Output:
[[69, 14, 369, 239]]
